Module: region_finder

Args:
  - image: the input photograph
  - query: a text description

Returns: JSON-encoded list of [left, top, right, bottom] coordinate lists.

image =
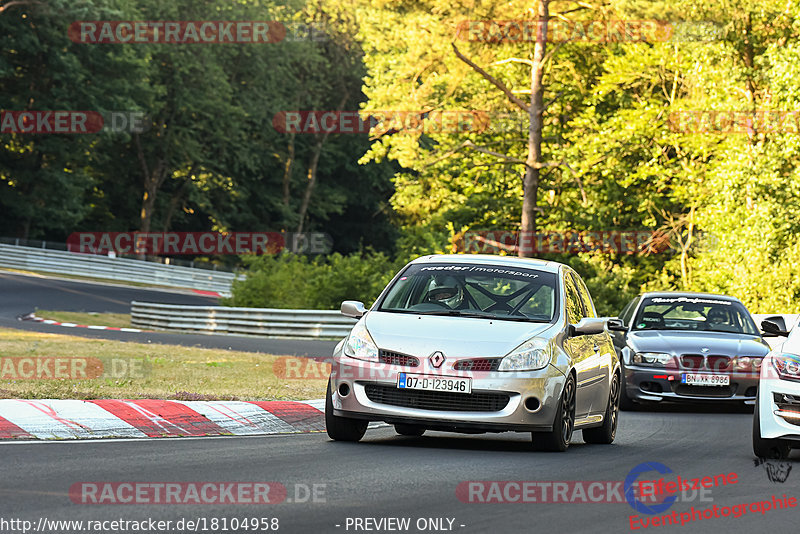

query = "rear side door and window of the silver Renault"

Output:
[[572, 272, 615, 414]]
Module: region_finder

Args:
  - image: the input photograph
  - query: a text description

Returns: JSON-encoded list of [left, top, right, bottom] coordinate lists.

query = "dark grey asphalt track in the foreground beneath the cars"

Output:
[[0, 408, 800, 534]]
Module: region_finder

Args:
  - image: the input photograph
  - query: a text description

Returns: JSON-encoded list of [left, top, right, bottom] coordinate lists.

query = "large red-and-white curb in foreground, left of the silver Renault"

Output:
[[0, 399, 325, 440]]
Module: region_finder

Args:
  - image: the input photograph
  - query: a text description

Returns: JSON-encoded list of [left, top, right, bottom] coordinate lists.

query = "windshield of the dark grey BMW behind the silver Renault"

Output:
[[633, 297, 758, 335]]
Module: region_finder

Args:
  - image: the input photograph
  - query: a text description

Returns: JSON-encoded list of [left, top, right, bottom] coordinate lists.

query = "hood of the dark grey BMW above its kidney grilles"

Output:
[[628, 330, 769, 356]]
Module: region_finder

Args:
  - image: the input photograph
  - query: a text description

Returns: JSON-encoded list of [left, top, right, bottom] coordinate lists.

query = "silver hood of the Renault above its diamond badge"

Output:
[[366, 311, 553, 359]]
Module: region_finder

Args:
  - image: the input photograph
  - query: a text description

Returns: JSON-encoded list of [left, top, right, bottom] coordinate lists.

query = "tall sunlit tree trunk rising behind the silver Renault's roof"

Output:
[[518, 0, 550, 257]]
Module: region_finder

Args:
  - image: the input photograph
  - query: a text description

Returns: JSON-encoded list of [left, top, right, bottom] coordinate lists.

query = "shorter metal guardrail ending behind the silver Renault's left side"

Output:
[[131, 301, 356, 338]]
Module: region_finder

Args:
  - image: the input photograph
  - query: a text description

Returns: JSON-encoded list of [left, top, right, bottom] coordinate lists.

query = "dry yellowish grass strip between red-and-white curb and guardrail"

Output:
[[0, 329, 328, 400]]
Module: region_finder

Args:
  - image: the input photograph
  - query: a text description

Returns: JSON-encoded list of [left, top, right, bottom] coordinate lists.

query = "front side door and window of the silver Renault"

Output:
[[564, 271, 596, 418]]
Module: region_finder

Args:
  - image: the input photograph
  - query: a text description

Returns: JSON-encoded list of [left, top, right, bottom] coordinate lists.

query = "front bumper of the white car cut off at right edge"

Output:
[[758, 358, 800, 446]]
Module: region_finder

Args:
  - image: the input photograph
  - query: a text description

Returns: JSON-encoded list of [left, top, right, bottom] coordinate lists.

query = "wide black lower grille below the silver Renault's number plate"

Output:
[[364, 384, 510, 412]]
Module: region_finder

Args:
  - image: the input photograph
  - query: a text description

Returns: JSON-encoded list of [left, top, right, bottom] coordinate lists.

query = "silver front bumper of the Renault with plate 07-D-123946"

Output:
[[331, 351, 566, 432]]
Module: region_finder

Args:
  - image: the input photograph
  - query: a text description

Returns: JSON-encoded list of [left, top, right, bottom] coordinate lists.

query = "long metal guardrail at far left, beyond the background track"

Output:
[[0, 243, 243, 296]]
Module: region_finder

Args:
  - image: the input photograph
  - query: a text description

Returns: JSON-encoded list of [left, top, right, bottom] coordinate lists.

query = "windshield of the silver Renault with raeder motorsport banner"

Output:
[[378, 264, 556, 322]]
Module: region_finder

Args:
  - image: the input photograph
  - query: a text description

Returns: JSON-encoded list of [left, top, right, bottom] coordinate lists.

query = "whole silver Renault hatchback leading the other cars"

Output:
[[325, 255, 621, 451]]
